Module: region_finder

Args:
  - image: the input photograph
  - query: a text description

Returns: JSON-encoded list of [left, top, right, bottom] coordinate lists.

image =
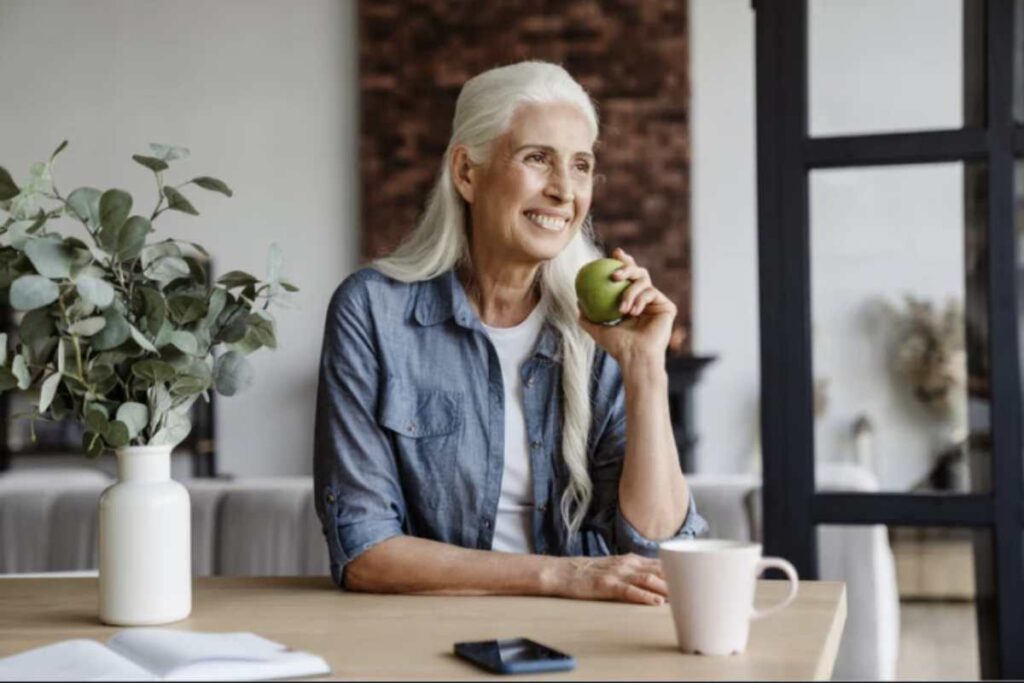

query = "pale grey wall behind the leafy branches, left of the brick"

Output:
[[0, 0, 359, 475]]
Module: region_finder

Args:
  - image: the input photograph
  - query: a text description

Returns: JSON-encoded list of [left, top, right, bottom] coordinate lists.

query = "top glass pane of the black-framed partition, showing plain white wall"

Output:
[[807, 0, 975, 136]]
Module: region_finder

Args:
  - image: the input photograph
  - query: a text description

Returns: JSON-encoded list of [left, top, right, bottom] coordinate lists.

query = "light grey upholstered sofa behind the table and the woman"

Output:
[[0, 466, 899, 680]]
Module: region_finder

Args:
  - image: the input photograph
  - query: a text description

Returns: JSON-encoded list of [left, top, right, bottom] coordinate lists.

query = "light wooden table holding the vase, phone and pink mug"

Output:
[[0, 578, 846, 680]]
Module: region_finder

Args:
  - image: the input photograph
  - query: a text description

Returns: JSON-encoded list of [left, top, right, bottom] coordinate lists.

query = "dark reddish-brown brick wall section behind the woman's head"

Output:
[[359, 0, 691, 351]]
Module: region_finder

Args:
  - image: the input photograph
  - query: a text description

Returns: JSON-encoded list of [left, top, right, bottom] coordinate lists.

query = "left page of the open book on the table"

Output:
[[0, 639, 157, 681]]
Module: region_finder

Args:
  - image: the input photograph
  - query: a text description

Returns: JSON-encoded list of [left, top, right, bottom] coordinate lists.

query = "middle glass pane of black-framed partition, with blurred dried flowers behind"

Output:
[[810, 163, 990, 493]]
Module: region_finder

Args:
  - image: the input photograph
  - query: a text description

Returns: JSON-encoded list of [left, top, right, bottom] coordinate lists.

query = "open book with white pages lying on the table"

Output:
[[0, 629, 331, 681]]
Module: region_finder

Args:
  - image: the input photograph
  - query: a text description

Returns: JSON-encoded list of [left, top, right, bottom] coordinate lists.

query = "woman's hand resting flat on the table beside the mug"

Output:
[[548, 553, 669, 605]]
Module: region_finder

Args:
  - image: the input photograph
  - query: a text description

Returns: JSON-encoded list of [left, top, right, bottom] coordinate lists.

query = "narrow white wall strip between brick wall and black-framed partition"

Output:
[[690, 0, 761, 473]]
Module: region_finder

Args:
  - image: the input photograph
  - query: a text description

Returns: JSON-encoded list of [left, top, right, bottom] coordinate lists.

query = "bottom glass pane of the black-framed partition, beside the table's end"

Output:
[[817, 524, 991, 681]]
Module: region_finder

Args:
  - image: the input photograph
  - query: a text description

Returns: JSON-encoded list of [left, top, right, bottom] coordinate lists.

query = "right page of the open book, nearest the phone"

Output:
[[108, 629, 330, 680]]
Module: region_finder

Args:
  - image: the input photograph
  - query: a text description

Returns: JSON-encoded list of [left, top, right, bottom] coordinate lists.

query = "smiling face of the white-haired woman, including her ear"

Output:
[[454, 102, 594, 264]]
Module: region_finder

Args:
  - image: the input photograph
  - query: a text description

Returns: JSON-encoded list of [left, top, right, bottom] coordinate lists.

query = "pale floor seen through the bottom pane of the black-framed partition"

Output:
[[896, 602, 981, 681]]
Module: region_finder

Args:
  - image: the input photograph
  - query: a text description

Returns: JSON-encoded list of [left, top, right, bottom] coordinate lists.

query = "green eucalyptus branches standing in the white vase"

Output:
[[0, 140, 297, 456]]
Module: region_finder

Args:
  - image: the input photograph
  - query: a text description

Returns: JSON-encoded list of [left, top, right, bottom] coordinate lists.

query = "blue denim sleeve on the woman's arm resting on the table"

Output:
[[313, 276, 406, 588]]
